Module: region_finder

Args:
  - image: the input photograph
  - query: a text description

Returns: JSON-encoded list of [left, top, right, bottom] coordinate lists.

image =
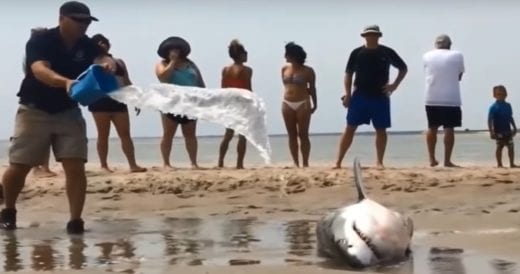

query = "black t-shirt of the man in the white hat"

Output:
[[346, 45, 406, 96]]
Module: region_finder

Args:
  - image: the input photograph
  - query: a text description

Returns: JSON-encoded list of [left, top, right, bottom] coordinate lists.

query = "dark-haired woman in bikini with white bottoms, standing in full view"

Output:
[[282, 42, 317, 167]]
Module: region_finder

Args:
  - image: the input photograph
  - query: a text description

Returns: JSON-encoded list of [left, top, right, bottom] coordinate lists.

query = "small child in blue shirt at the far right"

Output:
[[488, 85, 518, 167]]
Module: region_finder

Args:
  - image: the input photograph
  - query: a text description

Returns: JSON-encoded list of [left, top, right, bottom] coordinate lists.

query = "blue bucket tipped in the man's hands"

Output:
[[69, 65, 119, 106]]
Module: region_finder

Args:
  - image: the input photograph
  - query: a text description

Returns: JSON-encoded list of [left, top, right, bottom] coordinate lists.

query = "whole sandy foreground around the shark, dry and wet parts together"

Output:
[[0, 166, 520, 274]]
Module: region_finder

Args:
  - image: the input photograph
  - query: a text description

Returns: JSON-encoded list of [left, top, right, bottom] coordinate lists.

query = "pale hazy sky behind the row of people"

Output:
[[0, 0, 520, 140]]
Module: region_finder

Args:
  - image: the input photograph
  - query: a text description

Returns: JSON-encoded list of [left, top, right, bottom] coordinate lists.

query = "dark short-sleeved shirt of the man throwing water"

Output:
[[17, 27, 99, 113]]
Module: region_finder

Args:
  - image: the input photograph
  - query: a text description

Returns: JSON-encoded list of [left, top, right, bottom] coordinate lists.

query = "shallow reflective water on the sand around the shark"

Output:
[[0, 218, 520, 274]]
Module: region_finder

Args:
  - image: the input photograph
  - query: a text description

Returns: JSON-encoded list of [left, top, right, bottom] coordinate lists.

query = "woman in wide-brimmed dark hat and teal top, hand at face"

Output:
[[155, 37, 205, 169]]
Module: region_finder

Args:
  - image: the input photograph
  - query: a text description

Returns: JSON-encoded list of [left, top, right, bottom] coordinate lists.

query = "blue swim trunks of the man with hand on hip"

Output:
[[347, 91, 391, 129]]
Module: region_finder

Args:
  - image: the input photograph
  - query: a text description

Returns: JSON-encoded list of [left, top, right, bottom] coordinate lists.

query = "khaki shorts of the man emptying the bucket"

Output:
[[9, 105, 88, 166]]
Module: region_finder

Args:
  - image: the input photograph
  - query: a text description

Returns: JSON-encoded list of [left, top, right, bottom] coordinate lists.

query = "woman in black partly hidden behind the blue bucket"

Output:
[[88, 34, 146, 172]]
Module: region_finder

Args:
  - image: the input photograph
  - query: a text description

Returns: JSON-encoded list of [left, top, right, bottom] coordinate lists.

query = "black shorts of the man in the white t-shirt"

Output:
[[426, 106, 462, 128]]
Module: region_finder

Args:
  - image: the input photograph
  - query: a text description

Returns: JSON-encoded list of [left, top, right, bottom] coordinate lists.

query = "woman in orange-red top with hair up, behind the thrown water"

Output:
[[218, 40, 253, 169]]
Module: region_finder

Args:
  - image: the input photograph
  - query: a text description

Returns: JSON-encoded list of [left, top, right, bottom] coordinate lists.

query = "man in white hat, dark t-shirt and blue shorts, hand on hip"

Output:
[[336, 25, 408, 168]]
